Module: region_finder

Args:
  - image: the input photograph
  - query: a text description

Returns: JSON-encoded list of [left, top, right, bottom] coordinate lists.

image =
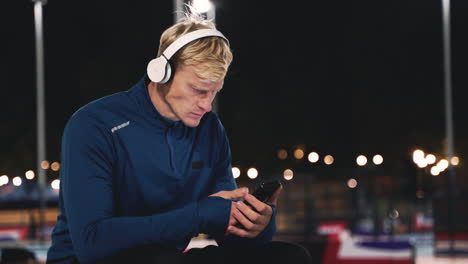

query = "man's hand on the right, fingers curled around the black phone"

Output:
[[226, 186, 283, 238]]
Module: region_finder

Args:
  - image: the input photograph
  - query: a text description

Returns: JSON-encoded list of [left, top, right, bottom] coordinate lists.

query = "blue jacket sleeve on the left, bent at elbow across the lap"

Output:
[[60, 112, 226, 263]]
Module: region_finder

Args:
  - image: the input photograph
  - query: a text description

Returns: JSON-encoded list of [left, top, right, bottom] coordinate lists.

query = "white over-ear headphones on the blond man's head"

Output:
[[146, 29, 229, 83]]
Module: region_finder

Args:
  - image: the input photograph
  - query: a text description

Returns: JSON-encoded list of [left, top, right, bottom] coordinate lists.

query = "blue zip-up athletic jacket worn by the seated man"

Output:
[[47, 75, 276, 263]]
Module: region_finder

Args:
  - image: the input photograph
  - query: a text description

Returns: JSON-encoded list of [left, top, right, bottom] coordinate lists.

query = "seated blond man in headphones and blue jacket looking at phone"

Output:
[[47, 11, 308, 263]]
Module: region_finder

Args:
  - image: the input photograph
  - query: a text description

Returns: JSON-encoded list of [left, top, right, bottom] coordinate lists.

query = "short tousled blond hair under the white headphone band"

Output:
[[158, 10, 232, 82]]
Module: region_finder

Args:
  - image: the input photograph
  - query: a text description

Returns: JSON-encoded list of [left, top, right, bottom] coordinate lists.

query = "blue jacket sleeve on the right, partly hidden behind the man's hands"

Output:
[[211, 118, 276, 247]]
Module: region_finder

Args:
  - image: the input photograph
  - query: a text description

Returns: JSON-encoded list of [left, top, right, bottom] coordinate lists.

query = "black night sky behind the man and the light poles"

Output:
[[0, 0, 468, 179]]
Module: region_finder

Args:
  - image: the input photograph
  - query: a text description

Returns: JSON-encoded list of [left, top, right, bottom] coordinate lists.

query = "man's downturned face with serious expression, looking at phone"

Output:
[[165, 65, 224, 127]]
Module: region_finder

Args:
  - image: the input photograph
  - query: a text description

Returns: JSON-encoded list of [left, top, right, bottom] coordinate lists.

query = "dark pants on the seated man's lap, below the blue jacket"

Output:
[[105, 241, 312, 264]]
